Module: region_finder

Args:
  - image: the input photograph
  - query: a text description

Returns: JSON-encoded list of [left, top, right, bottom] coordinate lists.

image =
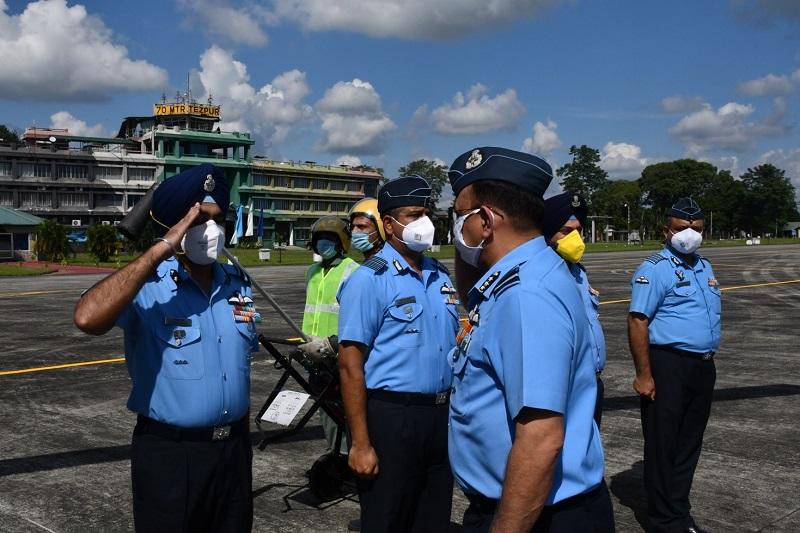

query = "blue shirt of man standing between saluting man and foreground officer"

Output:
[[338, 243, 458, 394]]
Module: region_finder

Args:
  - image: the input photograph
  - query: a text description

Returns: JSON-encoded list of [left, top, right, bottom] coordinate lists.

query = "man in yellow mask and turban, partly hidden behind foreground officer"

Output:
[[542, 192, 606, 427]]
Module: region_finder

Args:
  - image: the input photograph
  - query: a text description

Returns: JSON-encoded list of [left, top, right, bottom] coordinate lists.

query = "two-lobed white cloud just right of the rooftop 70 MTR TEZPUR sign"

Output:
[[197, 46, 313, 152]]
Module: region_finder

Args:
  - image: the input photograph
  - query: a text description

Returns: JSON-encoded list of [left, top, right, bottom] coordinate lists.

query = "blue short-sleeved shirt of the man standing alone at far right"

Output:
[[630, 246, 722, 353]]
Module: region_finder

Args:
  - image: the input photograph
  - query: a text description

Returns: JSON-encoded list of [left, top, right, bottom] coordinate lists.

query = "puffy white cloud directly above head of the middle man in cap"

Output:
[[315, 78, 396, 155]]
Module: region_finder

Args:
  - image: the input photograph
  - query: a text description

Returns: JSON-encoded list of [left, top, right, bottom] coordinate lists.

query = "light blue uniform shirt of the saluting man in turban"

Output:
[[117, 257, 258, 427]]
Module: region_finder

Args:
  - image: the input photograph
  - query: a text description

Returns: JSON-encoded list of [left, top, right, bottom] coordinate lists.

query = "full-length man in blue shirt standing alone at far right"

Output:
[[628, 198, 721, 532]]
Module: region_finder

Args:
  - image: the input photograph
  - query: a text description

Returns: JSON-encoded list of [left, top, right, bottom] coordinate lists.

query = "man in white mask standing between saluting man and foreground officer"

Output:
[[339, 176, 458, 533]]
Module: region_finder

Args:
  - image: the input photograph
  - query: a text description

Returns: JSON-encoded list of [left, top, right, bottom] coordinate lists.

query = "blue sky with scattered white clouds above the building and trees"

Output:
[[0, 0, 800, 197]]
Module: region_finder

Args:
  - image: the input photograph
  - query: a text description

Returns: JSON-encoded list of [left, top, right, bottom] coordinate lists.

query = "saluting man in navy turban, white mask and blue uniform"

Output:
[[74, 165, 260, 533]]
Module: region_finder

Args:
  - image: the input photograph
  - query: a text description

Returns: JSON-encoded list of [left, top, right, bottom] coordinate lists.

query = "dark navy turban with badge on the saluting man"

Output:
[[150, 163, 231, 227]]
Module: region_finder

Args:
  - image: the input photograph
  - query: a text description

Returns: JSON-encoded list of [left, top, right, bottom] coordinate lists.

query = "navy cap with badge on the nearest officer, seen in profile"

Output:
[[447, 146, 553, 198]]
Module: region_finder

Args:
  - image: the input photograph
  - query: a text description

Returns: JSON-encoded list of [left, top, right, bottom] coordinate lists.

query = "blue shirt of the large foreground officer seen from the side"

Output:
[[449, 237, 603, 505]]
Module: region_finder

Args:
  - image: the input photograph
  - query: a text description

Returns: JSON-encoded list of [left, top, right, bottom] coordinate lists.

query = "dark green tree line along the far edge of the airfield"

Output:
[[398, 145, 800, 239]]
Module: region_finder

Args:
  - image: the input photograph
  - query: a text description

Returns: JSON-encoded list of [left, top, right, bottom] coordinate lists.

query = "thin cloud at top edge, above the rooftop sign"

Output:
[[178, 0, 267, 46]]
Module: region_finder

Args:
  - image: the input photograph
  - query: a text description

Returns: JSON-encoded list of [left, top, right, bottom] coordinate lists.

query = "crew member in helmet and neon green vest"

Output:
[[299, 215, 358, 454]]
